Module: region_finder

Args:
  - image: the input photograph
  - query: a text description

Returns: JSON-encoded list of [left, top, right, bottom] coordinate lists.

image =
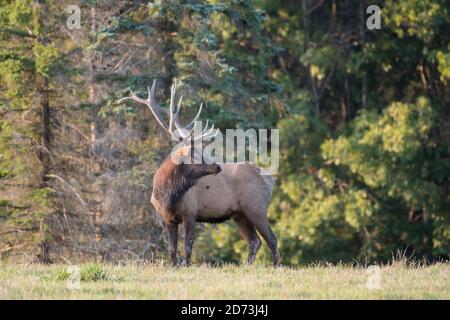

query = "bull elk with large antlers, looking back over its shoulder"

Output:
[[120, 80, 280, 266]]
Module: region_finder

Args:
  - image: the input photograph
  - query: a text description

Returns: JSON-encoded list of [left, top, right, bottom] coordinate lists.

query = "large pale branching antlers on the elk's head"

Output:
[[119, 79, 219, 141]]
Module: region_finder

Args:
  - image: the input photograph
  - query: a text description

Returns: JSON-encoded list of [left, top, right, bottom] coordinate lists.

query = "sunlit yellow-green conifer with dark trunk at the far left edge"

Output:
[[0, 0, 66, 262]]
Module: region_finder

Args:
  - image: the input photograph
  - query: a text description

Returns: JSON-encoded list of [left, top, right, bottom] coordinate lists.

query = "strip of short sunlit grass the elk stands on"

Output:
[[0, 262, 450, 299]]
